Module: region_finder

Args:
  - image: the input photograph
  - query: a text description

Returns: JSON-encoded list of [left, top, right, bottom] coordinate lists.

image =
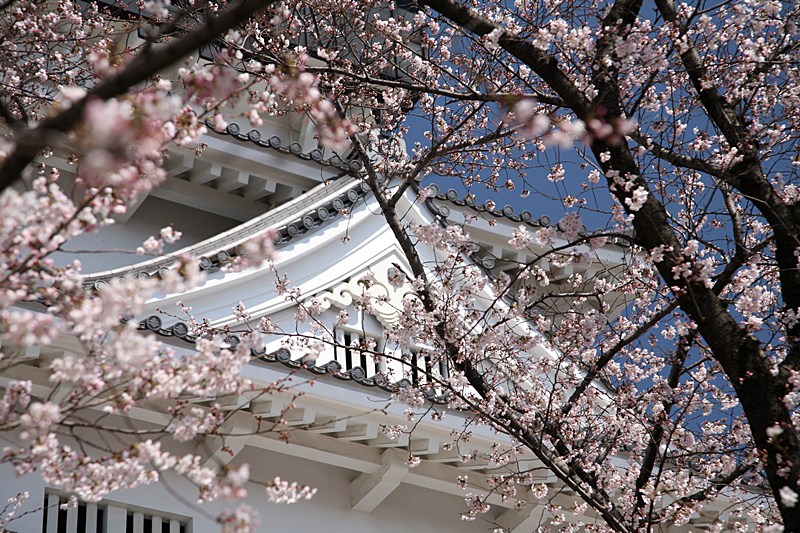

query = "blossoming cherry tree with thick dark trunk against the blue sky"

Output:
[[230, 0, 800, 530]]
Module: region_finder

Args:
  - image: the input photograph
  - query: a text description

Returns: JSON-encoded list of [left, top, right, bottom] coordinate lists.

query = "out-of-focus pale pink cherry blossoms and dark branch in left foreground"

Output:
[[0, 0, 322, 531]]
